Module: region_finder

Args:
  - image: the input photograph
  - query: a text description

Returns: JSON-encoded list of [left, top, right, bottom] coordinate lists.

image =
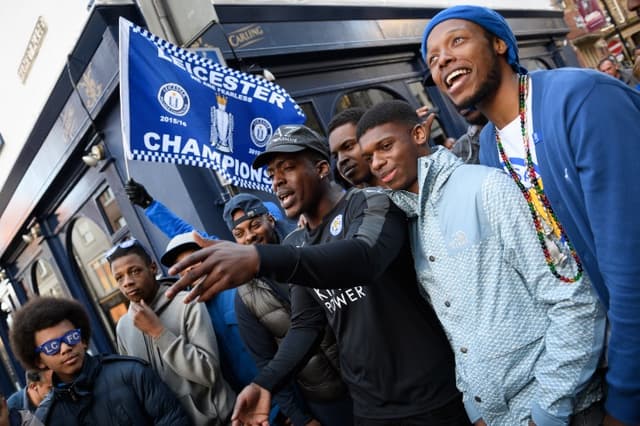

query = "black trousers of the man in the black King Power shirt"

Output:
[[355, 395, 471, 426]]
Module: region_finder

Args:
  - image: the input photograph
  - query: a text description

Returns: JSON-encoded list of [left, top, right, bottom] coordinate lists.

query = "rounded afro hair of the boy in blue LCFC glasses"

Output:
[[9, 296, 91, 370]]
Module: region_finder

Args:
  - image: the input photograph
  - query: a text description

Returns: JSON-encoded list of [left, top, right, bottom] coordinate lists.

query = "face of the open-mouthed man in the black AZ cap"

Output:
[[267, 152, 330, 218]]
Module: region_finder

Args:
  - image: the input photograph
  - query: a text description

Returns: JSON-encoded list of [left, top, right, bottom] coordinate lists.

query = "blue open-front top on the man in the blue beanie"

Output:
[[480, 68, 640, 424]]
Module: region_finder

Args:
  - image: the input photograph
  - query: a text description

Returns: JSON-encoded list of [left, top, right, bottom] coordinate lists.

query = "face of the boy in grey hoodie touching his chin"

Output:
[[111, 253, 158, 303]]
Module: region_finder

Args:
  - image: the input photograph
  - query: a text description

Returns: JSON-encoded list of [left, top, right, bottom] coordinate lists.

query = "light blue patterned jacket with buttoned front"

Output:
[[390, 149, 605, 426]]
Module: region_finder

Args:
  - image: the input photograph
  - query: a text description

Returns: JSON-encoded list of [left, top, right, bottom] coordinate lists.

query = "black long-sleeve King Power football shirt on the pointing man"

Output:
[[255, 189, 459, 419]]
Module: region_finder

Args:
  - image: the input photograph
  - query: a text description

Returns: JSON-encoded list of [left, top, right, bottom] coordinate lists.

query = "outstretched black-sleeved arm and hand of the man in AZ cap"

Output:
[[167, 190, 407, 301]]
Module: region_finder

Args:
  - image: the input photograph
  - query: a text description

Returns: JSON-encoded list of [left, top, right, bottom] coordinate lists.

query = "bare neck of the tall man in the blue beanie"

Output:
[[478, 64, 519, 129]]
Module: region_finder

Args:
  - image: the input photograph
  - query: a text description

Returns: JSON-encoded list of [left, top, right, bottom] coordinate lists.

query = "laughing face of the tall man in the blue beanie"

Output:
[[425, 19, 507, 109]]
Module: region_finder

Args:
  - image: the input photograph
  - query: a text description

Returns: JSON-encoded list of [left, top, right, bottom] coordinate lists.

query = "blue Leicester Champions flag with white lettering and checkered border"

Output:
[[120, 18, 305, 191]]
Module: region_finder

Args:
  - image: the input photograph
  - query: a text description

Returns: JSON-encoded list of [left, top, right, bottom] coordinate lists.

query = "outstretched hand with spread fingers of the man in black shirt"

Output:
[[166, 232, 260, 303]]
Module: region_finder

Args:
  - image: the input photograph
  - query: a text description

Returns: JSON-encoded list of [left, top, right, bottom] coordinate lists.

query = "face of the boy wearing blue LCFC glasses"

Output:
[[34, 320, 87, 383]]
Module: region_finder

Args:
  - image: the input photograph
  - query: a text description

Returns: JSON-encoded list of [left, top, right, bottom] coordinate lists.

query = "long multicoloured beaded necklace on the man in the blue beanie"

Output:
[[495, 75, 583, 283]]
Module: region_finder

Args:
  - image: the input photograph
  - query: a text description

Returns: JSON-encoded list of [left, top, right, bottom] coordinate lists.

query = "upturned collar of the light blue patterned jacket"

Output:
[[390, 147, 464, 218]]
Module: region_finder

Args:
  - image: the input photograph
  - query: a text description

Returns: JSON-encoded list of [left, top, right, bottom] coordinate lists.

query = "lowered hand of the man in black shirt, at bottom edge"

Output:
[[231, 383, 271, 426]]
